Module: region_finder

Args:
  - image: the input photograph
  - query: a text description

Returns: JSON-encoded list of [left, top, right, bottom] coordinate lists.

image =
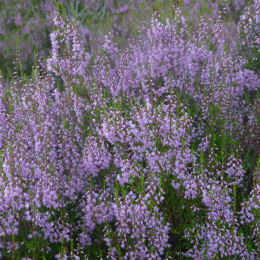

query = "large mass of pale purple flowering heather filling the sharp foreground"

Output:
[[0, 1, 260, 259]]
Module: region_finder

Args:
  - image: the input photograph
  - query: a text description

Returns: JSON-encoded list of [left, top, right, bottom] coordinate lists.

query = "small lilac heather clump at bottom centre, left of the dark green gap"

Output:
[[105, 182, 169, 259]]
